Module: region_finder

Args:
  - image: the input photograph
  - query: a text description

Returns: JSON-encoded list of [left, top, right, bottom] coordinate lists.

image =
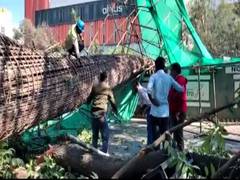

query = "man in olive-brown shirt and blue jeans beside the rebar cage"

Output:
[[87, 72, 117, 153]]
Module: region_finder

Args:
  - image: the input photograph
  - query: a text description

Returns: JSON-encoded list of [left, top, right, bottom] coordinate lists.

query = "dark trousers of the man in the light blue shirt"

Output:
[[149, 115, 169, 141]]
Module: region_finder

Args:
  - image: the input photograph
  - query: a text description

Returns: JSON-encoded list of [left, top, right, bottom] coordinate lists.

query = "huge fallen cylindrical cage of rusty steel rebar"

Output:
[[0, 34, 152, 140]]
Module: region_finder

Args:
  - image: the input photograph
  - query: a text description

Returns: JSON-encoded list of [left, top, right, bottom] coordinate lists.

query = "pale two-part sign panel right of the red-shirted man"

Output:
[[187, 81, 209, 101]]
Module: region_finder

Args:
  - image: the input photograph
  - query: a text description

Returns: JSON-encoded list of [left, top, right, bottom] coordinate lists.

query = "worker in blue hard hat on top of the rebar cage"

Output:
[[65, 19, 85, 58]]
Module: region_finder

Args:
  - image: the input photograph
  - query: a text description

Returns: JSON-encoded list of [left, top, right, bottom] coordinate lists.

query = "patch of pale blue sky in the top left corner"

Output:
[[0, 0, 24, 27]]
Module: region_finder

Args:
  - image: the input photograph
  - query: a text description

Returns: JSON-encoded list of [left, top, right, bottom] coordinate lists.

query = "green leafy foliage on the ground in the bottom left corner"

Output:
[[0, 142, 91, 179]]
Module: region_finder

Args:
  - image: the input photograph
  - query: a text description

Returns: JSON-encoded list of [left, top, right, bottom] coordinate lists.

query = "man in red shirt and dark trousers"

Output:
[[169, 63, 187, 150]]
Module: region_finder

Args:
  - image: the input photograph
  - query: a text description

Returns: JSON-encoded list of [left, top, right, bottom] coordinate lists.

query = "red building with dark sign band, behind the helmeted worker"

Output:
[[25, 0, 140, 46]]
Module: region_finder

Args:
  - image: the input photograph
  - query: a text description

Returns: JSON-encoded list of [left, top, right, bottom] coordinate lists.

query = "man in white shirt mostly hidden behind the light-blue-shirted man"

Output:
[[136, 82, 153, 145]]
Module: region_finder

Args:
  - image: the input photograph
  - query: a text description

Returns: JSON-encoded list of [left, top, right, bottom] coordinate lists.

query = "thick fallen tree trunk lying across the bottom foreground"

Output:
[[46, 140, 237, 179]]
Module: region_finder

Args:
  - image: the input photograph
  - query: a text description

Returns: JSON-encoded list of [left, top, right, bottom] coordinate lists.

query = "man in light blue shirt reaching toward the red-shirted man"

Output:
[[147, 57, 184, 140]]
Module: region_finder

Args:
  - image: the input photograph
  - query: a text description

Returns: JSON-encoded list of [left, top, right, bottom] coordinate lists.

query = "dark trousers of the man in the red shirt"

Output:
[[170, 112, 186, 151]]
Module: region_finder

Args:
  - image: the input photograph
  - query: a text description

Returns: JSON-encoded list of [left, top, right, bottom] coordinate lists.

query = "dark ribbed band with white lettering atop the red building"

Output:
[[35, 0, 134, 26]]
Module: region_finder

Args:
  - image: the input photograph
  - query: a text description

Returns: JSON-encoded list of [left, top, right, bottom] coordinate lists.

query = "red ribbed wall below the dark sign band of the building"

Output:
[[50, 17, 140, 46]]
